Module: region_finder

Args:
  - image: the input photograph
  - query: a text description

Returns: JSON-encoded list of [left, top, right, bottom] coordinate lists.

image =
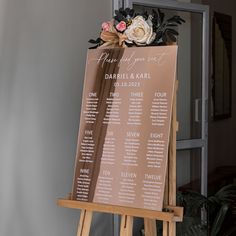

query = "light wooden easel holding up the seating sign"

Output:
[[57, 81, 183, 236]]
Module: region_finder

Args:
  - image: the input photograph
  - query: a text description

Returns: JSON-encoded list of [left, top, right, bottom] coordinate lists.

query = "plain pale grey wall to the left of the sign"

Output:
[[0, 0, 112, 236]]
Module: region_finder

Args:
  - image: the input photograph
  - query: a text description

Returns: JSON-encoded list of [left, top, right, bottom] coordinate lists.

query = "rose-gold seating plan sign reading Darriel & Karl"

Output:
[[72, 46, 177, 211]]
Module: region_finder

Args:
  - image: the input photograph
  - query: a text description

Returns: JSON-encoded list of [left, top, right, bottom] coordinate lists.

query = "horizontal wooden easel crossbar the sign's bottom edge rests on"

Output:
[[57, 199, 183, 222]]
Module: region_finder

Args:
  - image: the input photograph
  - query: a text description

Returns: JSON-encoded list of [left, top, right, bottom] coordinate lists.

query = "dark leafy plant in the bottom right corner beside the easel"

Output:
[[177, 184, 236, 236]]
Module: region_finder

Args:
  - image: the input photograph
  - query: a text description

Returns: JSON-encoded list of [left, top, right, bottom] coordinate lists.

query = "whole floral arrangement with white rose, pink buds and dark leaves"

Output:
[[89, 8, 185, 48]]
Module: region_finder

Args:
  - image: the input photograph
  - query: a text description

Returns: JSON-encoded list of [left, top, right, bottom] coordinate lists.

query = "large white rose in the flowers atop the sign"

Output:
[[124, 16, 156, 45]]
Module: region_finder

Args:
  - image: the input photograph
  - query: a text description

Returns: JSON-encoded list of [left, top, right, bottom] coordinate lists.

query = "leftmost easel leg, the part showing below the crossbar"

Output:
[[77, 210, 93, 236]]
